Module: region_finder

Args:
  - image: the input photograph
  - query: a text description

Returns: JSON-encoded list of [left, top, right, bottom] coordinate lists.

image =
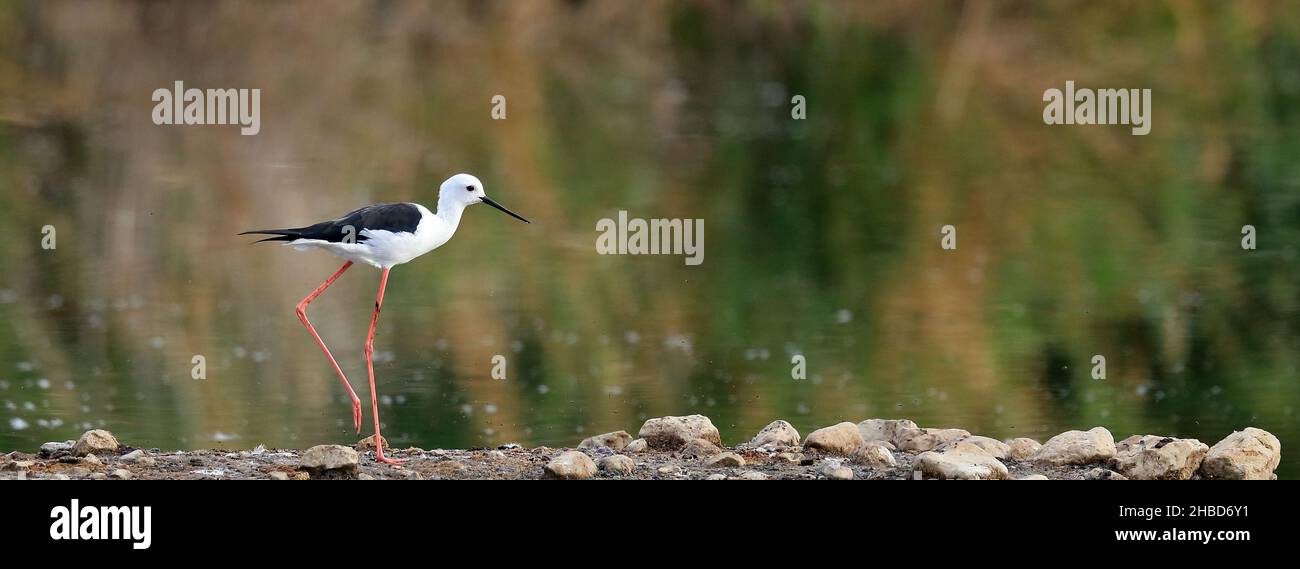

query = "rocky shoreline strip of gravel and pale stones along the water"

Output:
[[0, 414, 1282, 481]]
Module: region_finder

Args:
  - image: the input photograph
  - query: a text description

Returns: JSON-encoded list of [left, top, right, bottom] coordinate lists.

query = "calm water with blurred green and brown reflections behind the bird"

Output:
[[0, 3, 1300, 478]]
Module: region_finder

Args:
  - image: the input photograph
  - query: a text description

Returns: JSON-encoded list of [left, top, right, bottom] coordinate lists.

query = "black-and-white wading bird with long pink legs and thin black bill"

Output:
[[239, 174, 528, 464]]
